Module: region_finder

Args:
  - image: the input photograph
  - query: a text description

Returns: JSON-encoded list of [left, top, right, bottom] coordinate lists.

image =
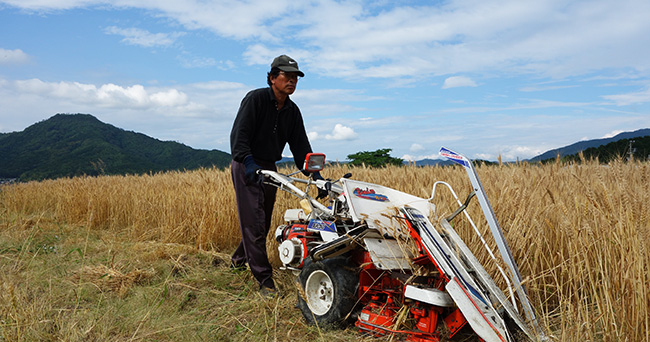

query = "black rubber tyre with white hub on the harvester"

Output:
[[298, 257, 359, 328]]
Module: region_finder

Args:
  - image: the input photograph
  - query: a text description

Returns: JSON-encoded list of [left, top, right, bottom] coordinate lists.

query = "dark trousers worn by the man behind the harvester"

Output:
[[230, 160, 277, 288]]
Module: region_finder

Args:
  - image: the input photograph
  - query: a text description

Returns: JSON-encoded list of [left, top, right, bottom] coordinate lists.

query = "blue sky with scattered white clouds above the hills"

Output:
[[0, 0, 650, 161]]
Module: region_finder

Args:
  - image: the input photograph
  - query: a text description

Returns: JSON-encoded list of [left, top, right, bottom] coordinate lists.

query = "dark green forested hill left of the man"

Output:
[[0, 114, 231, 180]]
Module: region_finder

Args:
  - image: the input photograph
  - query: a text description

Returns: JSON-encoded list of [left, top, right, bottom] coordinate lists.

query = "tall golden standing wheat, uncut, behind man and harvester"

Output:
[[0, 160, 650, 341]]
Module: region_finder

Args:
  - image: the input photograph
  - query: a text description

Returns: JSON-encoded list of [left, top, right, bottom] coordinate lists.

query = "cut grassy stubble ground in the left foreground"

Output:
[[0, 213, 372, 341]]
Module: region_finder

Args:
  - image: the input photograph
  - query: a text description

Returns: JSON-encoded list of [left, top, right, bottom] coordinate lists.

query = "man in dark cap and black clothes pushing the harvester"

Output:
[[230, 55, 320, 297]]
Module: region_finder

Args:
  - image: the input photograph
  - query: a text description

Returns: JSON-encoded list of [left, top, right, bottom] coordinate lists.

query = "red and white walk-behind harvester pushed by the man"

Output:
[[260, 148, 546, 342]]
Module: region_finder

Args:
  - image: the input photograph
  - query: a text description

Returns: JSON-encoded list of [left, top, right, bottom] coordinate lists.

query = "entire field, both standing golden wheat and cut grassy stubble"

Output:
[[0, 160, 650, 341]]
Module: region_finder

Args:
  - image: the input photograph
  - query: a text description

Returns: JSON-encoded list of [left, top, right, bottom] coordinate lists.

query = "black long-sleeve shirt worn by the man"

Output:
[[230, 87, 312, 168]]
